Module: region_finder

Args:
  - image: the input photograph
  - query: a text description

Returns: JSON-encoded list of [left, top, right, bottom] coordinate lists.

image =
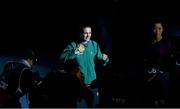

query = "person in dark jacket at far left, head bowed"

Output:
[[1, 50, 37, 108]]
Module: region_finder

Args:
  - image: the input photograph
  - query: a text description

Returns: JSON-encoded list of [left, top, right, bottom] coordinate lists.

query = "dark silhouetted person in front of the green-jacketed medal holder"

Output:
[[44, 60, 82, 108]]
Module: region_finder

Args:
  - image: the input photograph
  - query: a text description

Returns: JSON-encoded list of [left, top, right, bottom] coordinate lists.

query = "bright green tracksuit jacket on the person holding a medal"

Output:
[[60, 40, 109, 84]]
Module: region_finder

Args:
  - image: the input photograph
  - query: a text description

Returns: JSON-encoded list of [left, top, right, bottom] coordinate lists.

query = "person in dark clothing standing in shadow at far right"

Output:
[[144, 20, 171, 106]]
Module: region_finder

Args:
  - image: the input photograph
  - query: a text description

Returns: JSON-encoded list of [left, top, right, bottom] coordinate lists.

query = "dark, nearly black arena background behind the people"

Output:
[[0, 0, 180, 107]]
